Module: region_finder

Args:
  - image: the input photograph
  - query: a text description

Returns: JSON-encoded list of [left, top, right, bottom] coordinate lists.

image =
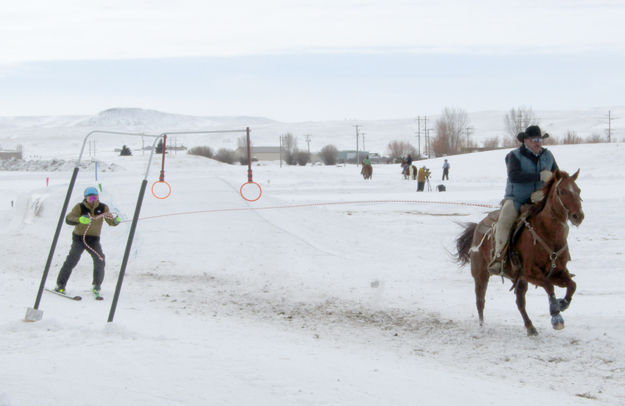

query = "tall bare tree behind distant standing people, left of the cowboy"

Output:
[[431, 107, 469, 156]]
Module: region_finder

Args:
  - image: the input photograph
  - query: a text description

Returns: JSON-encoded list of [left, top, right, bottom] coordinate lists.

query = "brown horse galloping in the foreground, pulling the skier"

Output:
[[456, 169, 584, 335]]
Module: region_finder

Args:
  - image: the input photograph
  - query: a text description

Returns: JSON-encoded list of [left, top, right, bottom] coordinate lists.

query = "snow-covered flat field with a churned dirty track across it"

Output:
[[0, 132, 625, 406]]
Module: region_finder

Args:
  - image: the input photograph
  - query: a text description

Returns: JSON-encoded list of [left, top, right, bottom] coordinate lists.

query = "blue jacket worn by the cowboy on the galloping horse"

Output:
[[504, 145, 558, 211]]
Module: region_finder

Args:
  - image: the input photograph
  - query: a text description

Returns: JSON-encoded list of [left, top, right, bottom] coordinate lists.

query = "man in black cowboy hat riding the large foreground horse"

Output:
[[488, 125, 558, 275]]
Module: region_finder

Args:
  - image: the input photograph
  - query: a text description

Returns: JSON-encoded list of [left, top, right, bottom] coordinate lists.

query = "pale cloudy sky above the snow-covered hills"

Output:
[[0, 0, 625, 121]]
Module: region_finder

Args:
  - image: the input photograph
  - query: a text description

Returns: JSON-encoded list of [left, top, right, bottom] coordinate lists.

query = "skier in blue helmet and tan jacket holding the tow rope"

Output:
[[54, 187, 121, 297]]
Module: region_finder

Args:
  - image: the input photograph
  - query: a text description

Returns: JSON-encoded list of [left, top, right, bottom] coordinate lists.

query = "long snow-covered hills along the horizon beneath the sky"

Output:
[[0, 107, 625, 154]]
